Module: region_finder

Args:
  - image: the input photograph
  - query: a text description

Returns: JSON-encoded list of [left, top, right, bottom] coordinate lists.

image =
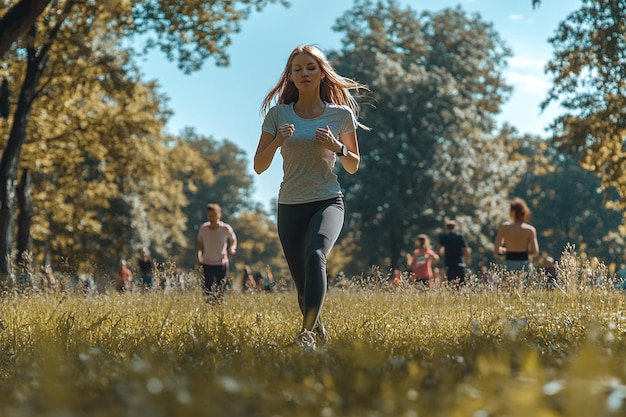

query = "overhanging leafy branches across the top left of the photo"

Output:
[[0, 0, 289, 69]]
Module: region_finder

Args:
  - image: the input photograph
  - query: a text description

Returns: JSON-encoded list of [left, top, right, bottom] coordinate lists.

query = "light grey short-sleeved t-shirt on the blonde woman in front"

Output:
[[263, 103, 357, 204]]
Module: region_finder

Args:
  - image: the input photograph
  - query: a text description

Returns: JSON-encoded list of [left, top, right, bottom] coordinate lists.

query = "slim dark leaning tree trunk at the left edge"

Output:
[[0, 37, 49, 279]]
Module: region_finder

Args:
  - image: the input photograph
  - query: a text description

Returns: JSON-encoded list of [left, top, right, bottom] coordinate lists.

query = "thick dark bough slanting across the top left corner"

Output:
[[0, 0, 50, 58]]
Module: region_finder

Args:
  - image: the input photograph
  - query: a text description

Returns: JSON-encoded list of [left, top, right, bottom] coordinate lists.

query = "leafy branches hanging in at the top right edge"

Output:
[[542, 0, 626, 231]]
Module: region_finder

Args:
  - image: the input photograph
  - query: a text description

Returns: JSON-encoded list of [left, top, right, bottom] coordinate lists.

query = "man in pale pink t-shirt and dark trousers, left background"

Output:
[[196, 203, 237, 302]]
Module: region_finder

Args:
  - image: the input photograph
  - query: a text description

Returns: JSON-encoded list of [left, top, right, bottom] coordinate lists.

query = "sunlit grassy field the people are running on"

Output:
[[0, 255, 626, 417]]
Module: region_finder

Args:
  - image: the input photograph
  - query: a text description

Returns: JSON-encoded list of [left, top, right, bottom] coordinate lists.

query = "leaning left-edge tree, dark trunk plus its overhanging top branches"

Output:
[[0, 0, 286, 276]]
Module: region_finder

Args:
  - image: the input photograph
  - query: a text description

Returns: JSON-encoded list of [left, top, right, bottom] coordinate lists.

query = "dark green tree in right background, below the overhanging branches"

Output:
[[513, 137, 626, 265]]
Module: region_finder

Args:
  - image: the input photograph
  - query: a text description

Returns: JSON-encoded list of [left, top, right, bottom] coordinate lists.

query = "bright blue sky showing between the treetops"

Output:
[[142, 0, 581, 207]]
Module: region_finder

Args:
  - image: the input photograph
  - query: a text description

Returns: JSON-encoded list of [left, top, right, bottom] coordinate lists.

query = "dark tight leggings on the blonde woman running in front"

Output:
[[278, 197, 344, 330]]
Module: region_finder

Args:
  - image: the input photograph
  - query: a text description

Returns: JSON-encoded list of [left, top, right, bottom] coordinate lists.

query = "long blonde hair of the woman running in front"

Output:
[[261, 45, 370, 130]]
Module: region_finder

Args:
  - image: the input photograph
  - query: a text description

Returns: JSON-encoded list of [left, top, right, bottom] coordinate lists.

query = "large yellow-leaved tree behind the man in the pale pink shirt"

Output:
[[9, 38, 212, 268]]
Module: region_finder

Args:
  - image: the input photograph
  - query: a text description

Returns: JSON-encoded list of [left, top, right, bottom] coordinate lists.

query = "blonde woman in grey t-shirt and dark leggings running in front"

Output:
[[254, 45, 367, 349]]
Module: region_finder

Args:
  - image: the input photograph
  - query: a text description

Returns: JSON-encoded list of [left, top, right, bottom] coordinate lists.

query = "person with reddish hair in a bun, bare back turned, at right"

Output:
[[494, 198, 539, 273]]
